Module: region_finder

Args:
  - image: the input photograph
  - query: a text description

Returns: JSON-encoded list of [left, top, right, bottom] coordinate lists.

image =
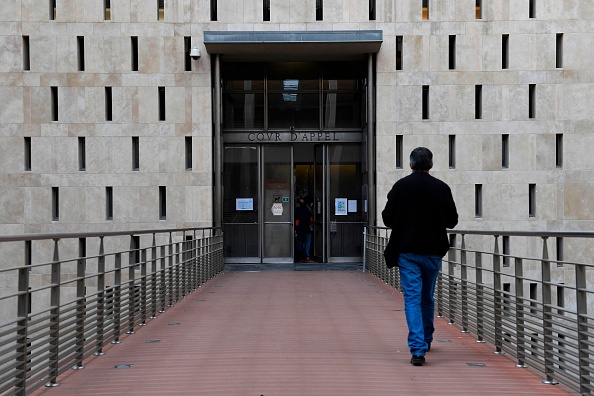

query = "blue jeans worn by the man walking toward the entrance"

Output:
[[398, 253, 442, 356]]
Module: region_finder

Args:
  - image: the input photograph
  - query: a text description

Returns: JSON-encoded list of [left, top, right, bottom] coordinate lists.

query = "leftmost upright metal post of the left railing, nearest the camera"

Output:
[[15, 242, 31, 396]]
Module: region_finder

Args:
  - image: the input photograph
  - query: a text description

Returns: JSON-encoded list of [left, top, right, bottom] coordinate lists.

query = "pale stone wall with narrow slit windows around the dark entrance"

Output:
[[0, 0, 594, 256]]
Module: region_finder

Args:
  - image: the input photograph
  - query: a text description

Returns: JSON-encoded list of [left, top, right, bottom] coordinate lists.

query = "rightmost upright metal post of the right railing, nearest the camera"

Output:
[[575, 264, 592, 395]]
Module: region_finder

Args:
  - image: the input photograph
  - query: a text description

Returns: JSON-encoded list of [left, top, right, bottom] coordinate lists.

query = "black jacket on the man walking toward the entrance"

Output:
[[382, 172, 458, 268]]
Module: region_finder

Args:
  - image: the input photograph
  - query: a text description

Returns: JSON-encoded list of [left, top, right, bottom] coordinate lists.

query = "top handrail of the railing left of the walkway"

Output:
[[0, 227, 222, 242]]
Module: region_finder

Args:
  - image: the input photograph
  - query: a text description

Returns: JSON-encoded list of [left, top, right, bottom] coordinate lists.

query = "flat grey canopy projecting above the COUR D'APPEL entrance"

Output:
[[204, 30, 383, 61]]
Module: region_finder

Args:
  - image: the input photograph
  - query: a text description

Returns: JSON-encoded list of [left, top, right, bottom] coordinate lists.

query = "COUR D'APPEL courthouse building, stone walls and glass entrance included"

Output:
[[0, 0, 594, 263]]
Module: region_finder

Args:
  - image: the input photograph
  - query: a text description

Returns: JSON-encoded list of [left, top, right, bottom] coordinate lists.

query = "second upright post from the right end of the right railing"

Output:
[[541, 237, 558, 385]]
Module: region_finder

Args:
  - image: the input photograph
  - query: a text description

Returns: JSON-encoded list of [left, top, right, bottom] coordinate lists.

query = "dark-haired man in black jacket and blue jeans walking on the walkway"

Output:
[[382, 147, 458, 366]]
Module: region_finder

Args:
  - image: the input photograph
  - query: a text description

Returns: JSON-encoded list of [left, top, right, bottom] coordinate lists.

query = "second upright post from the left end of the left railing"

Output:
[[45, 239, 62, 387]]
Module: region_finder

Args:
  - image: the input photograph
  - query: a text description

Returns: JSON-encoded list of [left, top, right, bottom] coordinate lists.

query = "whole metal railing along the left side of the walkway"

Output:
[[0, 228, 224, 395]]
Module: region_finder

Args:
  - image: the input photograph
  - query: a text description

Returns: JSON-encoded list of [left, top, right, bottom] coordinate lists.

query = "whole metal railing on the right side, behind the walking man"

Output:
[[364, 227, 594, 394]]
